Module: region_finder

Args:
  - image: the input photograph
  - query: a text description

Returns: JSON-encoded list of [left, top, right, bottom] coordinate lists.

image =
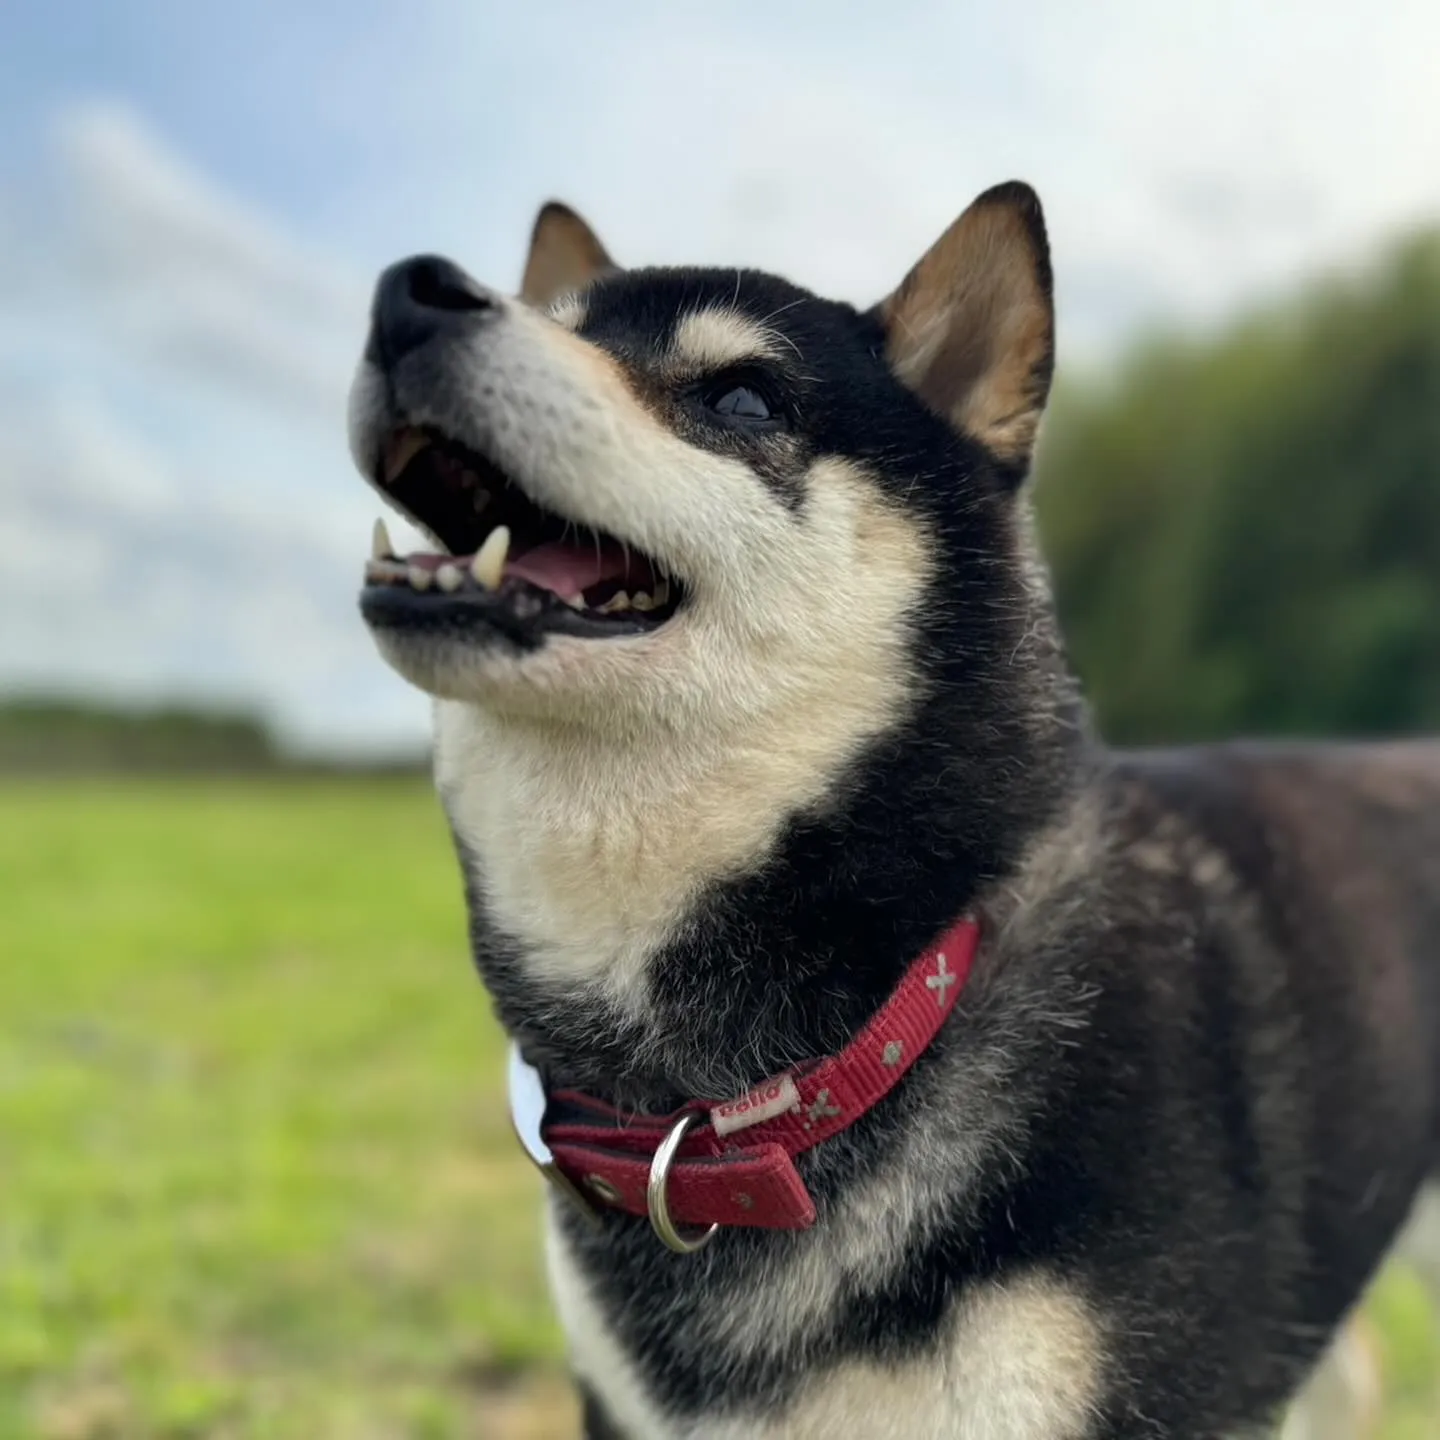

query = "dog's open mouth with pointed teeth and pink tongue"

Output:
[[360, 426, 683, 645]]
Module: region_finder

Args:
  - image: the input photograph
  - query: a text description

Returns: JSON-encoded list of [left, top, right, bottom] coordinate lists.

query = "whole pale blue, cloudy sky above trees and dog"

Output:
[[0, 0, 1440, 749]]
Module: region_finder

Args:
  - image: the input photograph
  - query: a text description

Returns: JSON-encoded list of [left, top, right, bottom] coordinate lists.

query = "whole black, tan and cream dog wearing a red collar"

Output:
[[342, 183, 1440, 1440]]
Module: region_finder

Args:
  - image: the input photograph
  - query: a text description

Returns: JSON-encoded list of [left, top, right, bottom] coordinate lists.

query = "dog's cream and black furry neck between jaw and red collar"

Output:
[[436, 555, 1089, 1103]]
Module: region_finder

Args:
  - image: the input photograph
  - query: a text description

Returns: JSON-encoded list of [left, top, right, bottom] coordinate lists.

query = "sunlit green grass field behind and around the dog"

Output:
[[0, 782, 1440, 1440]]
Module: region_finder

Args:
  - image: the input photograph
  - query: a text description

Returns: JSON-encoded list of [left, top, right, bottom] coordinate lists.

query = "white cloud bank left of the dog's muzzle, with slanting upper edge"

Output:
[[0, 107, 426, 749]]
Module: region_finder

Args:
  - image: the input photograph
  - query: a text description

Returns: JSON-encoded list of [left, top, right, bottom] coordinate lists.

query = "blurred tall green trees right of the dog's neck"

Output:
[[1037, 235, 1440, 743]]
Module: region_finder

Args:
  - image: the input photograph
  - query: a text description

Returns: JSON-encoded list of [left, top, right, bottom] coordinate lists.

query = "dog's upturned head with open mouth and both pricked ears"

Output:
[[351, 184, 1053, 727]]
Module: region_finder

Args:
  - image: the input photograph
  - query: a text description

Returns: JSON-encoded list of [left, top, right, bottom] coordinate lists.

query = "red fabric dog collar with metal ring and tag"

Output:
[[510, 916, 979, 1250]]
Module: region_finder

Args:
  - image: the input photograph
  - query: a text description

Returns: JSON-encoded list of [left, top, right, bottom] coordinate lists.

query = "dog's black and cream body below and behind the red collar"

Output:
[[552, 746, 1440, 1440]]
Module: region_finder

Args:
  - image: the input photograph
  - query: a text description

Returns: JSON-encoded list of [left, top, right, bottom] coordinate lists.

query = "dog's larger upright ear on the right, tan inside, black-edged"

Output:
[[876, 180, 1054, 475]]
